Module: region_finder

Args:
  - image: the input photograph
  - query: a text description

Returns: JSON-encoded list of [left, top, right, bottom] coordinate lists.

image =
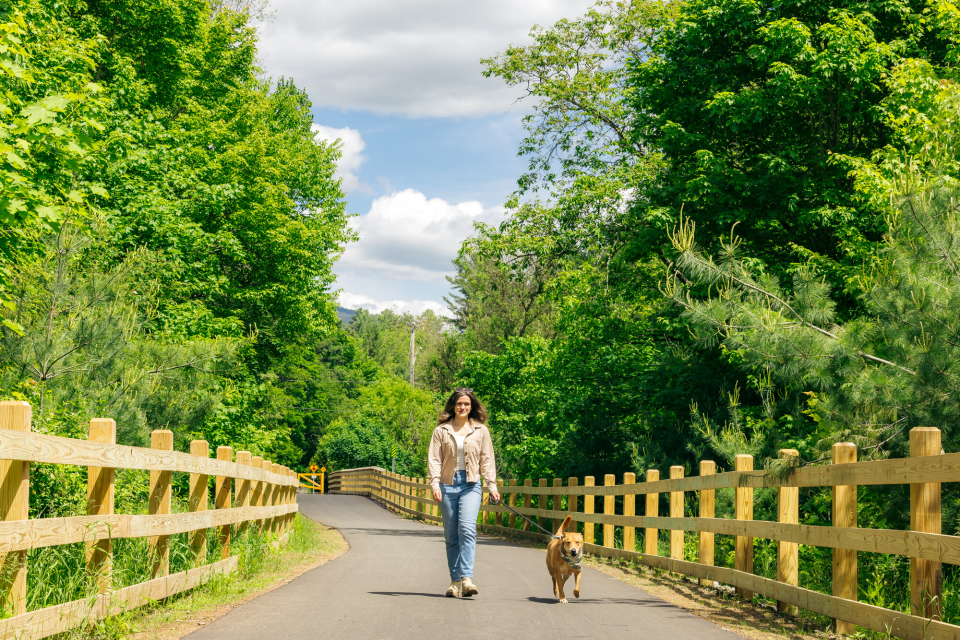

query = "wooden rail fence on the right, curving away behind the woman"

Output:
[[329, 428, 960, 640]]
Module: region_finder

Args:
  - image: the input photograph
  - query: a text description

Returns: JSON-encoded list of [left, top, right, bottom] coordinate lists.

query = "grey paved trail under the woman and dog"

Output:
[[189, 494, 739, 640]]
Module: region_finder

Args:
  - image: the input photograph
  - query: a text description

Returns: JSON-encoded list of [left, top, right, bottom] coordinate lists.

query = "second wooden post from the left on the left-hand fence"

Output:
[[87, 418, 117, 593]]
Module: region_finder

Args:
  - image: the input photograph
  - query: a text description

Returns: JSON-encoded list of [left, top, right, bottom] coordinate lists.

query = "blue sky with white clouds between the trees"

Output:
[[260, 0, 593, 315]]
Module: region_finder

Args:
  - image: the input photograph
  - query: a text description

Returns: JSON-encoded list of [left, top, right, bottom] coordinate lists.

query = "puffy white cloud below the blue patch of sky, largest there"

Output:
[[337, 189, 504, 282]]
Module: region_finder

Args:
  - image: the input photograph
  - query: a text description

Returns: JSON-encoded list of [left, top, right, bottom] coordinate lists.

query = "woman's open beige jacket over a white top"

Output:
[[427, 420, 497, 491]]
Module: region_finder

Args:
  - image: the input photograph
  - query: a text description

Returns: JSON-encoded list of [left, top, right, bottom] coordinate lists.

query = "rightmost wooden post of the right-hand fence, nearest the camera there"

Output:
[[910, 427, 943, 618]]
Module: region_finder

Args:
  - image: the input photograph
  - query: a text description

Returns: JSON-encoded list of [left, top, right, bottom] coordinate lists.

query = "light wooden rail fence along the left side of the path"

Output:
[[0, 402, 298, 640]]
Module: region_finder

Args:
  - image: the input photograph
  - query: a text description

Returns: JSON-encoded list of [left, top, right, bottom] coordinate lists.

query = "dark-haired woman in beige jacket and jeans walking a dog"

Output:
[[427, 387, 500, 598]]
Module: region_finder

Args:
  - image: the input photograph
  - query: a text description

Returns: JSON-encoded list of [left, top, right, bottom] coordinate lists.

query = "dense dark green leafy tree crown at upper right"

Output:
[[629, 0, 928, 296]]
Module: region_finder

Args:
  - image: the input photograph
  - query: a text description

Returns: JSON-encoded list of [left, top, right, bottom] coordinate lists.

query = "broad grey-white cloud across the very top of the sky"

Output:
[[259, 0, 594, 117]]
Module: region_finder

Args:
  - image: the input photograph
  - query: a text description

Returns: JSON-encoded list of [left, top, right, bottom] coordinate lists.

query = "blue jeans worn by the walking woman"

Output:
[[440, 471, 483, 580]]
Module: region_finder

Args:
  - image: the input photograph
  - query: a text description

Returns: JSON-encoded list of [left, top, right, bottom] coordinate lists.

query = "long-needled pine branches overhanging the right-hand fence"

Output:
[[667, 159, 960, 456]]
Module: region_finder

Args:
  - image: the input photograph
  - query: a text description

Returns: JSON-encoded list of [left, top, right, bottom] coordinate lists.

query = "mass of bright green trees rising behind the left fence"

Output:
[[0, 0, 354, 465]]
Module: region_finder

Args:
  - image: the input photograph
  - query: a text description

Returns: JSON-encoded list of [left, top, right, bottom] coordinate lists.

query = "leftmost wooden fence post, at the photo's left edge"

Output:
[[0, 400, 32, 616]]
